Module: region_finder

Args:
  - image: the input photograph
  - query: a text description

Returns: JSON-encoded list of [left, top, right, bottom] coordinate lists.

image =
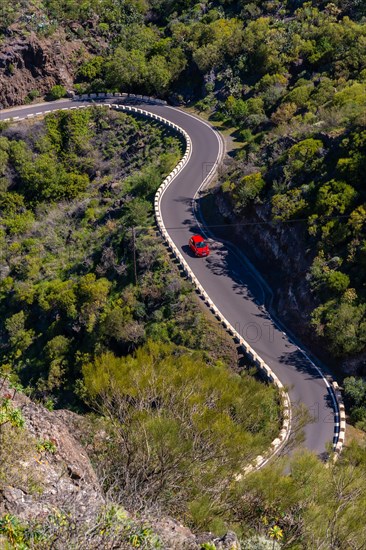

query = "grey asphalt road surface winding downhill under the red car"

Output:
[[0, 100, 337, 457]]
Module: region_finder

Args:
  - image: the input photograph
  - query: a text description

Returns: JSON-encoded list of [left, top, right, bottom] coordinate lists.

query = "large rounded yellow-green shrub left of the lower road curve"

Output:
[[83, 342, 278, 521]]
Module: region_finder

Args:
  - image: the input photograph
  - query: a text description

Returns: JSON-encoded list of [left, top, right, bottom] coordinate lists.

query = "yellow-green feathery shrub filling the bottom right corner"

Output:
[[235, 444, 366, 550]]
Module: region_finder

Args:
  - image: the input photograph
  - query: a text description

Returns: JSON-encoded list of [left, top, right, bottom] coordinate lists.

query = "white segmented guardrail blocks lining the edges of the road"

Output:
[[4, 94, 346, 470]]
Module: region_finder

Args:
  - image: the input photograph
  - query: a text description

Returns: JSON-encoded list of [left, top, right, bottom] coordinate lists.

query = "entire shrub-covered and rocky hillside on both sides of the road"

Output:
[[0, 0, 366, 550]]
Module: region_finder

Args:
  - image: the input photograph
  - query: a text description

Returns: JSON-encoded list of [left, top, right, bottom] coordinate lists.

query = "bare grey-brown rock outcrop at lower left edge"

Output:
[[0, 387, 105, 521]]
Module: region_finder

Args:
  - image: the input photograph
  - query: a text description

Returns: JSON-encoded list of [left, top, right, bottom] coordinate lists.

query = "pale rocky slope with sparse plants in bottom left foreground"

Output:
[[0, 378, 244, 550]]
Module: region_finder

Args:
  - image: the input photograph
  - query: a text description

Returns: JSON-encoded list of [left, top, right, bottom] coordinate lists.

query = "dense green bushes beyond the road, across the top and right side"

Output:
[[1, 0, 366, 357]]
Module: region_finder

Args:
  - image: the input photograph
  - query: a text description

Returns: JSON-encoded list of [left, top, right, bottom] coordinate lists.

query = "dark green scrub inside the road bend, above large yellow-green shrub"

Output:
[[0, 109, 194, 406]]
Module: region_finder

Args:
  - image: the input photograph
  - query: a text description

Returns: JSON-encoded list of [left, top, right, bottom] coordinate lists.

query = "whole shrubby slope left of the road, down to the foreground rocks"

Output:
[[0, 107, 280, 548]]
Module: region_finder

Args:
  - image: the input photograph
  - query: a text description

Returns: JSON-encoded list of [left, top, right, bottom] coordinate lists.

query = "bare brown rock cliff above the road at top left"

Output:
[[0, 30, 85, 108]]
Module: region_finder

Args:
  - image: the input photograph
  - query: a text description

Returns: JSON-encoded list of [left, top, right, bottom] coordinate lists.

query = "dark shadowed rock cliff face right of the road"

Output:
[[212, 191, 338, 366]]
